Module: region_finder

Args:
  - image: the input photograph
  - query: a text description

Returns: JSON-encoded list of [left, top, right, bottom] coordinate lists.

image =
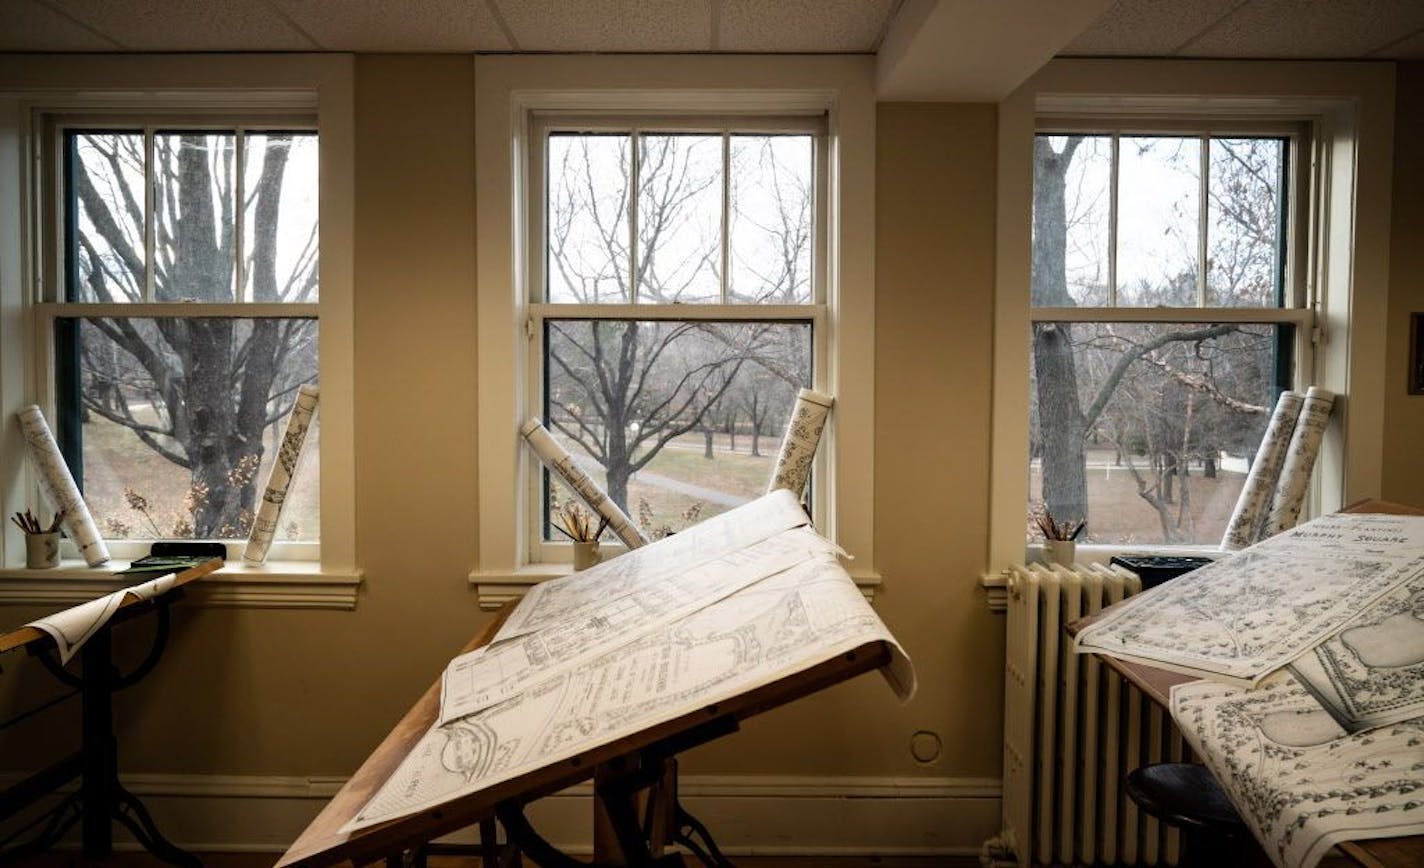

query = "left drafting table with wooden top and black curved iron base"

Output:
[[0, 558, 222, 865]]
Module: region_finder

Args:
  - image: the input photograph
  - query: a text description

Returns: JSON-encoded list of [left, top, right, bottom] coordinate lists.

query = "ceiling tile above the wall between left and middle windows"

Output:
[[272, 0, 511, 51]]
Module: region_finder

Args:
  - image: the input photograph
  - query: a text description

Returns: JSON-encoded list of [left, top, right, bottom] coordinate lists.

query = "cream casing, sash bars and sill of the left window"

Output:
[[0, 55, 360, 609]]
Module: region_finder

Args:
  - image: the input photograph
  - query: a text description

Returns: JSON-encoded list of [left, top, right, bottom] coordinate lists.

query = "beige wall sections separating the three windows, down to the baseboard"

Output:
[[0, 57, 1002, 777]]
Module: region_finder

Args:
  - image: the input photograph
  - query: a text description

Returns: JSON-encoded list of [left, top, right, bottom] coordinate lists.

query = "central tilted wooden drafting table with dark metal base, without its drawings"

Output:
[[278, 603, 891, 868]]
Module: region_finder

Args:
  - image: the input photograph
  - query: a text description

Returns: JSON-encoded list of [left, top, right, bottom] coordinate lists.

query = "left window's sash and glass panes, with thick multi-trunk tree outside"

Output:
[[51, 122, 320, 546]]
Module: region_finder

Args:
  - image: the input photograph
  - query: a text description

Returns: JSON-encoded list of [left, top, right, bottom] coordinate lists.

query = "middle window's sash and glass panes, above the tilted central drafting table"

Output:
[[530, 118, 824, 559]]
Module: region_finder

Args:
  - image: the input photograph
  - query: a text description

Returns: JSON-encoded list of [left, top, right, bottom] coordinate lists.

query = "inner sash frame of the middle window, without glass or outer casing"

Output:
[[524, 112, 829, 563]]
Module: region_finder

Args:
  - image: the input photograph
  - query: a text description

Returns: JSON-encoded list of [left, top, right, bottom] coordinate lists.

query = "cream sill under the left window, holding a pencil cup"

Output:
[[0, 559, 362, 609]]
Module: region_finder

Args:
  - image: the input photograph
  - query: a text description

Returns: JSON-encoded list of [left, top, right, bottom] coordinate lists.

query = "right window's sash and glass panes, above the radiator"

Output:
[[1028, 131, 1309, 545]]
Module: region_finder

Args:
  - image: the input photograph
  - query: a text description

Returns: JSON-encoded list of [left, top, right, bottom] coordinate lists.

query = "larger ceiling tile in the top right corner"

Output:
[[1182, 0, 1424, 58]]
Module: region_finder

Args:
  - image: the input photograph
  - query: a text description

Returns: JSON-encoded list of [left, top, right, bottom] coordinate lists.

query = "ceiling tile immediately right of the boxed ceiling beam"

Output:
[[1059, 0, 1242, 57]]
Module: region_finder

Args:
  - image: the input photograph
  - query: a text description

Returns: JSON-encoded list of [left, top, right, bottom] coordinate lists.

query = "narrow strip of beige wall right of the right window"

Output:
[[1380, 63, 1424, 507]]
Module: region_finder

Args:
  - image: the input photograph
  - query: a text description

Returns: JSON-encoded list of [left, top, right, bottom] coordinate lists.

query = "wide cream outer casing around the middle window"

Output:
[[470, 55, 880, 608]]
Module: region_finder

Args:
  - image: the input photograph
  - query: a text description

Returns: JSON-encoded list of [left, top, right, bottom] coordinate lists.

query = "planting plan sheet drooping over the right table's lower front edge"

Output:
[[1172, 673, 1424, 868]]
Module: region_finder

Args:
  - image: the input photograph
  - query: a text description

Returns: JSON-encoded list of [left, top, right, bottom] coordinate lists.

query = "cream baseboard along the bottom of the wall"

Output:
[[0, 774, 1000, 855]]
